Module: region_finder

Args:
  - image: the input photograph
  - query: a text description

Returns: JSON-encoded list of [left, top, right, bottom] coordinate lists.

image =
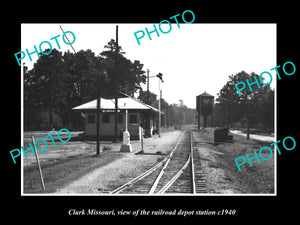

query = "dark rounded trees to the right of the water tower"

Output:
[[214, 71, 274, 132]]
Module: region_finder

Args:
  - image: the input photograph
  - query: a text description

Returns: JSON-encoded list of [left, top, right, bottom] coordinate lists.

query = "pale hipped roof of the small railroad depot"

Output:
[[73, 97, 159, 112]]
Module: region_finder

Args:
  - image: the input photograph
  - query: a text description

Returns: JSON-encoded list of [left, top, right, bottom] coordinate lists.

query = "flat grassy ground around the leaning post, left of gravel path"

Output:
[[23, 131, 122, 193]]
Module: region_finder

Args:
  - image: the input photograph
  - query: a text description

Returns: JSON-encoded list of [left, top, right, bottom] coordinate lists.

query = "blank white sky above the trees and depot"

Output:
[[21, 22, 277, 108]]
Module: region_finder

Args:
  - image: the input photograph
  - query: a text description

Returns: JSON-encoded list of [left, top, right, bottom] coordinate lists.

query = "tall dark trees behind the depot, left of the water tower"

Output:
[[24, 39, 195, 130]]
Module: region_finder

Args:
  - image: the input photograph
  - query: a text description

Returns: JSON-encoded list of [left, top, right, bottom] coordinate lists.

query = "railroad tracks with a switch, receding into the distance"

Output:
[[110, 130, 207, 194]]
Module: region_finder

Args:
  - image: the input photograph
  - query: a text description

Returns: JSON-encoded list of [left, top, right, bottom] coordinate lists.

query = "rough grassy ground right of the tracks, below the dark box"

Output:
[[216, 135, 274, 193]]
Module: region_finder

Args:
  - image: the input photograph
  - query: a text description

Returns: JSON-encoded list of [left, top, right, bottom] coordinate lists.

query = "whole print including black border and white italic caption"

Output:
[[3, 7, 298, 224]]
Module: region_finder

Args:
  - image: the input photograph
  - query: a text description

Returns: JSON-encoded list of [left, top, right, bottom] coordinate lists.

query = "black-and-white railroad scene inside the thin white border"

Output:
[[19, 22, 276, 195]]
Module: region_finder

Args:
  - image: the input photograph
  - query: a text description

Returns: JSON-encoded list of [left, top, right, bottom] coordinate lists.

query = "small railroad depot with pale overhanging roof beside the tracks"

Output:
[[73, 96, 159, 140]]
